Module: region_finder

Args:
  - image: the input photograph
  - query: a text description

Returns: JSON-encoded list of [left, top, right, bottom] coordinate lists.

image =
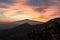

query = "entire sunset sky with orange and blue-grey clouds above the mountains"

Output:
[[0, 0, 60, 22]]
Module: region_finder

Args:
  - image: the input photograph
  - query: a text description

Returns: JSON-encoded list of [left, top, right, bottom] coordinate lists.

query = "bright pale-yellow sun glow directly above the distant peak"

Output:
[[5, 12, 46, 22]]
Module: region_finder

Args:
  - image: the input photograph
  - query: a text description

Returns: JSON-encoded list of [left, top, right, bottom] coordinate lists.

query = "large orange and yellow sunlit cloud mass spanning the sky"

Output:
[[0, 0, 60, 22]]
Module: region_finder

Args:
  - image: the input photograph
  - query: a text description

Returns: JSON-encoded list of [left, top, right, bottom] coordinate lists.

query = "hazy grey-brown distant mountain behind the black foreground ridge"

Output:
[[0, 19, 43, 30]]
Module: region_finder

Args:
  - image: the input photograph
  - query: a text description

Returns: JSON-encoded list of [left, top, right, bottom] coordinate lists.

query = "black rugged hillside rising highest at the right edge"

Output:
[[28, 18, 60, 40]]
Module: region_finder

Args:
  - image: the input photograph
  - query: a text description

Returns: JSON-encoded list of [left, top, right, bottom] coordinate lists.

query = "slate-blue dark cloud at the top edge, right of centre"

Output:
[[27, 0, 49, 6]]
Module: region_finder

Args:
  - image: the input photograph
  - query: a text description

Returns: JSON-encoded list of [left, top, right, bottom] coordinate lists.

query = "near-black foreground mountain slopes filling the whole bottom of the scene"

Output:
[[0, 18, 60, 40]]
